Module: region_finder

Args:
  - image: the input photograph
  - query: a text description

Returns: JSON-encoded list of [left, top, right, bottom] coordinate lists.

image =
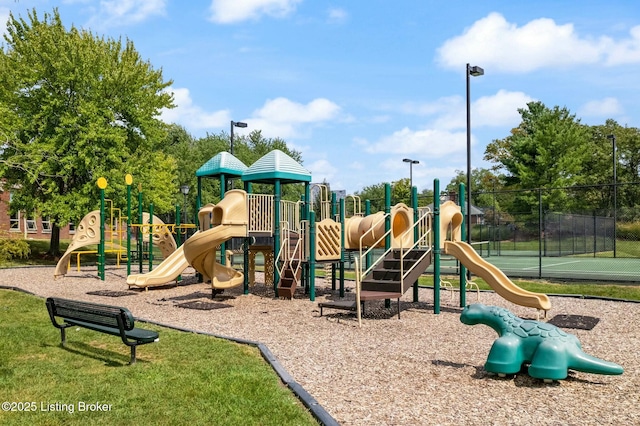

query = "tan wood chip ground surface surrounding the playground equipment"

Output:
[[0, 267, 640, 425]]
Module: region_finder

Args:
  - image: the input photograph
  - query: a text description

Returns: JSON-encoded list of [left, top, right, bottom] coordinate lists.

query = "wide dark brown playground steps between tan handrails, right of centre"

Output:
[[360, 249, 431, 302]]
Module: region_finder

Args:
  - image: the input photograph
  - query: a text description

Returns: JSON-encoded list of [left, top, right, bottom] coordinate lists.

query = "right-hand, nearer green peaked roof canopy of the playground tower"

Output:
[[242, 149, 311, 183]]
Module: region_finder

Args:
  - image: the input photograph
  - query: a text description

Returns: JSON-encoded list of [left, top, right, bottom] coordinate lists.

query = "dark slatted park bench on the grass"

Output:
[[46, 297, 159, 364]]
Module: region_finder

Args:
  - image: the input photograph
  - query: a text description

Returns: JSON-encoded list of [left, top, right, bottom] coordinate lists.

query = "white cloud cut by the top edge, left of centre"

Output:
[[209, 0, 302, 24]]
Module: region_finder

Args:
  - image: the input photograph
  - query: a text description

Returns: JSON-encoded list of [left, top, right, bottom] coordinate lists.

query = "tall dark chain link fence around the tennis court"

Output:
[[471, 183, 640, 282]]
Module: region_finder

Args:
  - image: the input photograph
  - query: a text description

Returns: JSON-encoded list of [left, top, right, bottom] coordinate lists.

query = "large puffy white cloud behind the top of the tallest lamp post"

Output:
[[438, 12, 608, 73]]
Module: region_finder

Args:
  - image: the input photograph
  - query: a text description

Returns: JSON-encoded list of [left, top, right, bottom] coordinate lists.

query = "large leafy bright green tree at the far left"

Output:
[[0, 9, 175, 255]]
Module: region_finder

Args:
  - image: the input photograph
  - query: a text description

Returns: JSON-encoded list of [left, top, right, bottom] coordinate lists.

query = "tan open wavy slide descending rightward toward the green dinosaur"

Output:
[[444, 241, 551, 311]]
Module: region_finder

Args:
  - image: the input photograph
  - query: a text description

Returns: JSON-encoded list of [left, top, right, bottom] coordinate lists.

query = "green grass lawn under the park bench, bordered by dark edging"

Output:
[[0, 290, 317, 425]]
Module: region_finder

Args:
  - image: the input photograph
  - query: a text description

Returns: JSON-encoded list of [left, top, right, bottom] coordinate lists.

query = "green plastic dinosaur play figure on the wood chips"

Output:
[[460, 303, 623, 382]]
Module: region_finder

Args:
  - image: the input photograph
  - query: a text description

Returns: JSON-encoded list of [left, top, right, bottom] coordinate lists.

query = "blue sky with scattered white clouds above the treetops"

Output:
[[0, 0, 640, 193]]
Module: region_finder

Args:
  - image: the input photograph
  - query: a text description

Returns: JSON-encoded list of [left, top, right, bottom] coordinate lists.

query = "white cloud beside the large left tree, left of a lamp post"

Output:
[[160, 87, 231, 131]]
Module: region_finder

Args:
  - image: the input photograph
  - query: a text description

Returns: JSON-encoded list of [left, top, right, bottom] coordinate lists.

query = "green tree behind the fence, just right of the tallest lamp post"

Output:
[[484, 102, 591, 213]]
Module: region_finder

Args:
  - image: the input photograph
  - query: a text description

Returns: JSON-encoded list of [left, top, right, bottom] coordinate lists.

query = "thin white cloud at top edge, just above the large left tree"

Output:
[[87, 0, 167, 28]]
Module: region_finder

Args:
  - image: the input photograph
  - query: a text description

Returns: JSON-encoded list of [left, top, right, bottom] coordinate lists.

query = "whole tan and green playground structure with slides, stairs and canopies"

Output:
[[55, 150, 550, 322]]
